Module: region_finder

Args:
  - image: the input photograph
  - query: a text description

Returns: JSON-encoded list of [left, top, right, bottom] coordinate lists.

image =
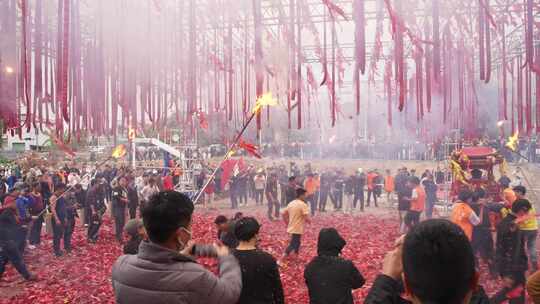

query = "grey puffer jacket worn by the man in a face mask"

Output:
[[112, 241, 242, 304]]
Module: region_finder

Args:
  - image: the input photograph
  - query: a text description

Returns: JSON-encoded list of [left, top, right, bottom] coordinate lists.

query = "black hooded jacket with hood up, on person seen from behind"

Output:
[[304, 228, 366, 304]]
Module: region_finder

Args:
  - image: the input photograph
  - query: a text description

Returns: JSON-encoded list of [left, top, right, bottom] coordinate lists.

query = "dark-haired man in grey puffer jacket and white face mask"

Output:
[[112, 191, 242, 304]]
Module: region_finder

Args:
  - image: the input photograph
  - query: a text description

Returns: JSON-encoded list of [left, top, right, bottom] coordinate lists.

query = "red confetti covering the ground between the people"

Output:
[[0, 212, 524, 304]]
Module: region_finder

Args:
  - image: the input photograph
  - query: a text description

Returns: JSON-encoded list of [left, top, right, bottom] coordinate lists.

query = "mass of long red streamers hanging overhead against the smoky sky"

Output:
[[0, 0, 540, 152]]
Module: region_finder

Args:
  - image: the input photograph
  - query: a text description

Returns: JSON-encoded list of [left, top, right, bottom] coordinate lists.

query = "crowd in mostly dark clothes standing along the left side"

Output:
[[0, 164, 181, 279]]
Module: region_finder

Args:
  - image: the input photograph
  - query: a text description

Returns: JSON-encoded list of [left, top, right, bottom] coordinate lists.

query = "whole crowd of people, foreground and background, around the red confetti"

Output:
[[0, 158, 540, 303]]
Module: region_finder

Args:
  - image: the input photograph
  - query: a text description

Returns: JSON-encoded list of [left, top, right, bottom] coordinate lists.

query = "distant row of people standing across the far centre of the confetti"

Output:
[[224, 163, 442, 222]]
